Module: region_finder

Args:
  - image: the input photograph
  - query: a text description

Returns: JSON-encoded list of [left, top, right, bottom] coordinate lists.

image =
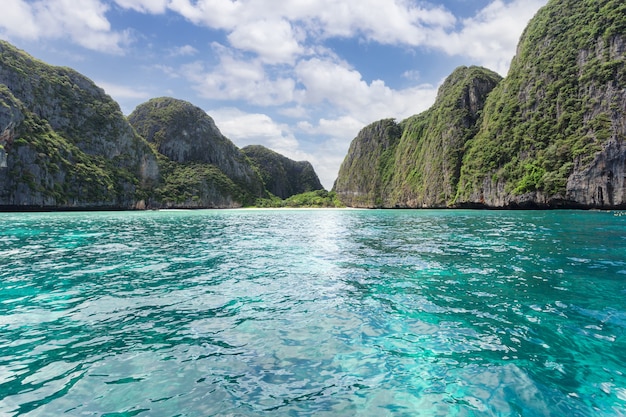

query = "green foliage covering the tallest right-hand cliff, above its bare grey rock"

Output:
[[458, 0, 626, 200]]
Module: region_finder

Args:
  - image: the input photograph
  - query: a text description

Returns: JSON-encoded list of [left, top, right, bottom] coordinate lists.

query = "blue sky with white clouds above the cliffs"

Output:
[[0, 0, 547, 189]]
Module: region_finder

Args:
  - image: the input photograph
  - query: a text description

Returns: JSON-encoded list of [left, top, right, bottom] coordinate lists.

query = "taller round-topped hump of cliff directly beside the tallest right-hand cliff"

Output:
[[386, 67, 502, 207]]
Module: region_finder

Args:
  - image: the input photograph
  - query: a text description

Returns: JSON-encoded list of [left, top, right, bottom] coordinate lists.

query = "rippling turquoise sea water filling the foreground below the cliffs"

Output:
[[0, 210, 626, 417]]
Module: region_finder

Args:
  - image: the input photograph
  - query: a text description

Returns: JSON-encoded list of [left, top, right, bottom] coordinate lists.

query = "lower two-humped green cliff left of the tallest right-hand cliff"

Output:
[[334, 67, 501, 208]]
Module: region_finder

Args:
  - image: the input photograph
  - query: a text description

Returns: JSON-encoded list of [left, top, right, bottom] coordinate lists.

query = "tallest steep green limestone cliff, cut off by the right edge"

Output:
[[456, 0, 626, 208]]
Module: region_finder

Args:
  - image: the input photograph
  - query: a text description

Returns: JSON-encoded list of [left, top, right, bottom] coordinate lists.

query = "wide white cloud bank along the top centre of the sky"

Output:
[[127, 0, 456, 63]]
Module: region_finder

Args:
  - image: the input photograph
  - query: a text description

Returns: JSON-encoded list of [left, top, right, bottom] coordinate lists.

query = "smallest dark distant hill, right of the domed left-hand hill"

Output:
[[242, 145, 324, 199]]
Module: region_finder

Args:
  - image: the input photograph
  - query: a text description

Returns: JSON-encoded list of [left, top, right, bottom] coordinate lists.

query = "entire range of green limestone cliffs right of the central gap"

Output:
[[334, 0, 626, 208]]
